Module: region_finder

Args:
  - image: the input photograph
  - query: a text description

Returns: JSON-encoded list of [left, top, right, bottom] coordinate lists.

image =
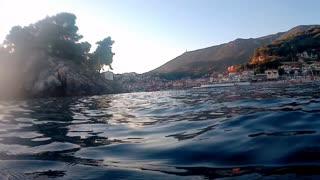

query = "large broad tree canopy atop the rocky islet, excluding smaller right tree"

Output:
[[3, 13, 91, 61]]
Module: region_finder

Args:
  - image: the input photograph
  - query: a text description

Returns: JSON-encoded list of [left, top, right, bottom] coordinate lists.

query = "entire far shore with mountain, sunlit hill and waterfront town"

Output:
[[105, 25, 320, 92]]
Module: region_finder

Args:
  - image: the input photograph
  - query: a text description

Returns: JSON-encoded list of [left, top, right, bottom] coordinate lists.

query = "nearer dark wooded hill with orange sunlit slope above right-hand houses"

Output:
[[249, 25, 320, 68]]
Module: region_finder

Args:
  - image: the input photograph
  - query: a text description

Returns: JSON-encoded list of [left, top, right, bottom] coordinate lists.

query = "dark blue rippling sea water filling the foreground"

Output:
[[0, 83, 320, 179]]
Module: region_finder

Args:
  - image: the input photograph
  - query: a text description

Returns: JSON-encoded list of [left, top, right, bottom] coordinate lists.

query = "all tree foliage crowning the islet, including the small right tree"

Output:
[[2, 13, 114, 72]]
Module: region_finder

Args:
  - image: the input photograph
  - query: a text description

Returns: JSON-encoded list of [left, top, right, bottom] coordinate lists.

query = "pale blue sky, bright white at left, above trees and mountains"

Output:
[[0, 0, 320, 73]]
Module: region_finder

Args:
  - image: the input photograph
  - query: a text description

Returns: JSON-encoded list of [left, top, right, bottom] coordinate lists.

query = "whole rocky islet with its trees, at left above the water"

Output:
[[0, 13, 121, 98]]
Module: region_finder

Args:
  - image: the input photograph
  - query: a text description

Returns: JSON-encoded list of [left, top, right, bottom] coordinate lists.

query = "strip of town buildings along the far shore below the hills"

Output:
[[104, 52, 320, 92]]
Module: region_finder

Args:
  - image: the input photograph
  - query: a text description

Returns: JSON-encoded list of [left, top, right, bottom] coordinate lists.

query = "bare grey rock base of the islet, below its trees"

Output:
[[0, 57, 121, 98]]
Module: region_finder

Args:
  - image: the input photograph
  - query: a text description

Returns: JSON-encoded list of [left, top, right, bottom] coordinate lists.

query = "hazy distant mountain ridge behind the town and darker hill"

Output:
[[146, 25, 315, 79]]
